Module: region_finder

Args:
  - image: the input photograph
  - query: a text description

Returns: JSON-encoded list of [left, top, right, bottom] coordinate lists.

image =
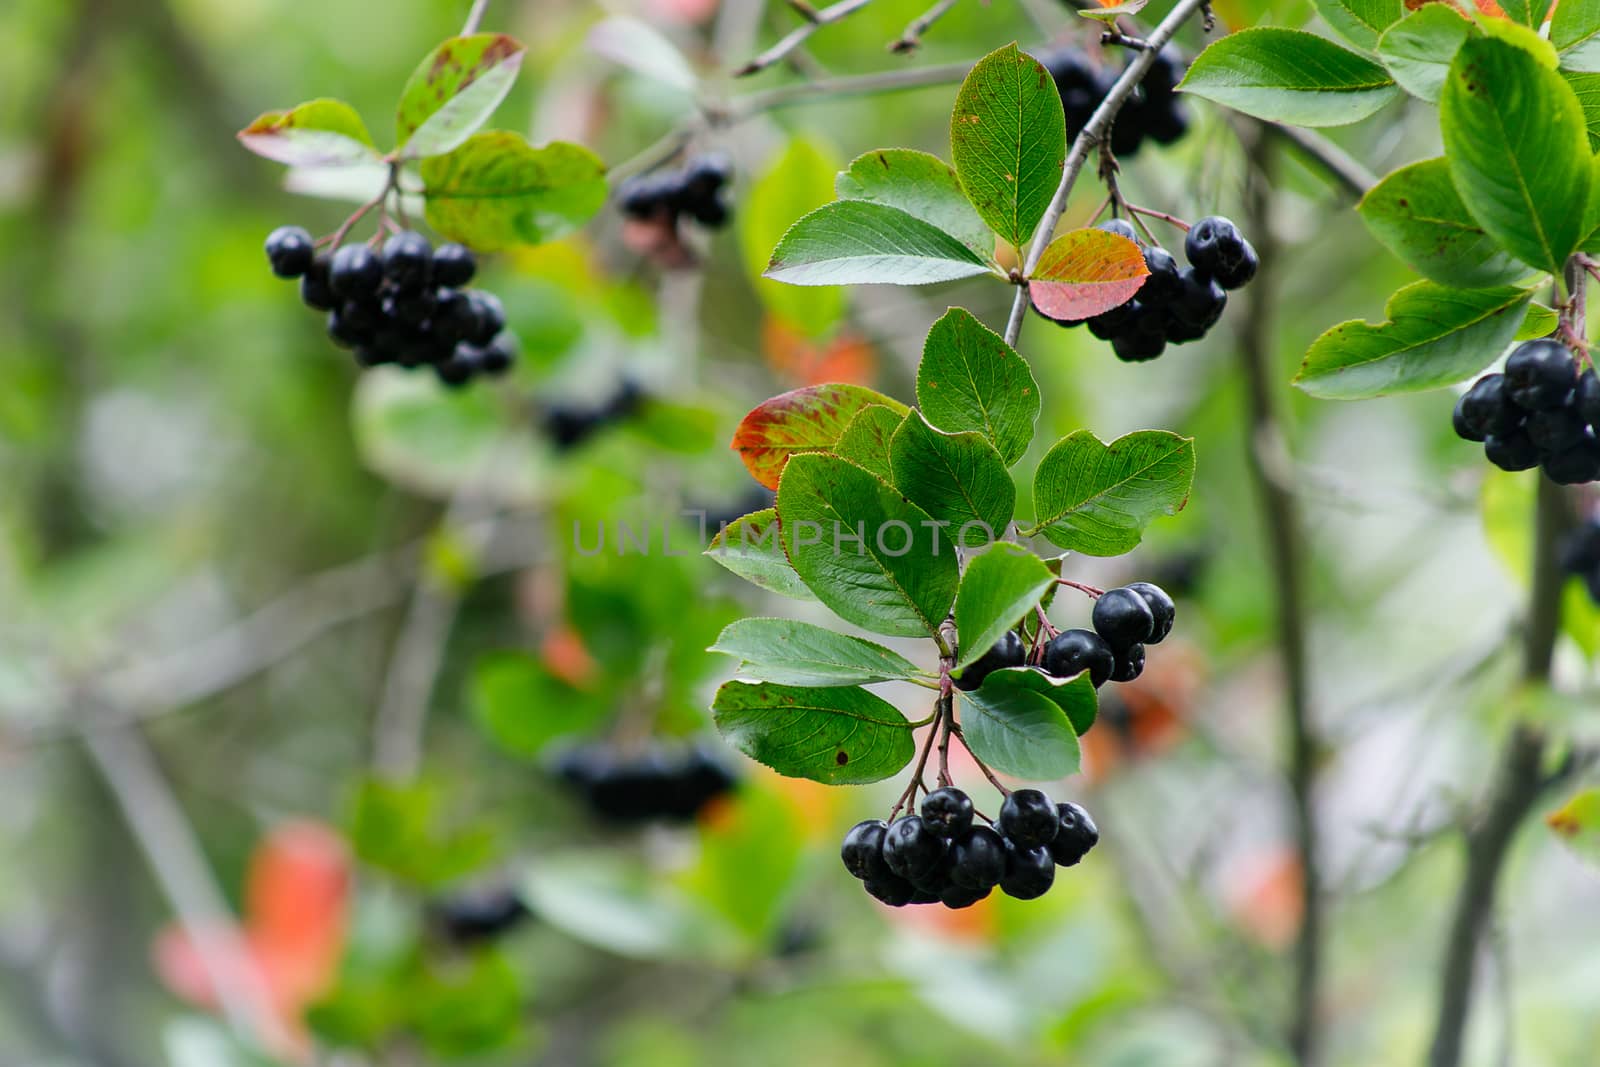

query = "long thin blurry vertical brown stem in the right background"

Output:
[[1238, 123, 1323, 1064]]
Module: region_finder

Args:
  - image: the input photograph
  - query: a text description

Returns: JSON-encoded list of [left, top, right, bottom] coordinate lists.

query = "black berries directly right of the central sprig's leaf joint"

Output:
[[955, 582, 1178, 693]]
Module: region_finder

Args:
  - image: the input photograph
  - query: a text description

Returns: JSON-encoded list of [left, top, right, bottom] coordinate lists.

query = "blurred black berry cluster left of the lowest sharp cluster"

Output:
[[555, 744, 738, 822]]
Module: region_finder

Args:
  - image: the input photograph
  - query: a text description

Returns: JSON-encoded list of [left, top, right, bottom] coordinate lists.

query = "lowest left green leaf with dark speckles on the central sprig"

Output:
[[712, 681, 914, 785]]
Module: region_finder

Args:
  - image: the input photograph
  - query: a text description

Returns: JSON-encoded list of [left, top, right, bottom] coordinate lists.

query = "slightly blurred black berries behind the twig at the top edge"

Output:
[[1038, 45, 1189, 155]]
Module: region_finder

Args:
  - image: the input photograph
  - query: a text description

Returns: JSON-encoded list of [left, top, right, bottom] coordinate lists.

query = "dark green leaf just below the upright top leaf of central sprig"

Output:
[[890, 414, 1016, 547]]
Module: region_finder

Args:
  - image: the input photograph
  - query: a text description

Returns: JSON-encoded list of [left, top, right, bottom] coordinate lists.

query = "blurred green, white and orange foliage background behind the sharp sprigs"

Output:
[[0, 0, 1600, 1067]]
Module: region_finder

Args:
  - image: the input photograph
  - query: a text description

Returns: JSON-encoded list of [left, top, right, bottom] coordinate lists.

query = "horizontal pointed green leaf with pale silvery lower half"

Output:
[[766, 200, 990, 285]]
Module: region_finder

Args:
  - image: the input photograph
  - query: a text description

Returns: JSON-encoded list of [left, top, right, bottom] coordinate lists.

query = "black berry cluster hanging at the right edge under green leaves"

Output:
[[1453, 339, 1600, 485]]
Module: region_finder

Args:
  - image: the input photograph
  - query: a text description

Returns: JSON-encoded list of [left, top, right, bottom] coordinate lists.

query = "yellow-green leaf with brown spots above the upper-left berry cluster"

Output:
[[422, 130, 606, 251]]
